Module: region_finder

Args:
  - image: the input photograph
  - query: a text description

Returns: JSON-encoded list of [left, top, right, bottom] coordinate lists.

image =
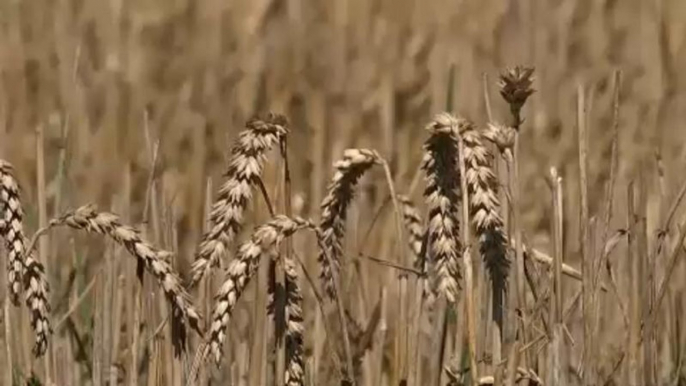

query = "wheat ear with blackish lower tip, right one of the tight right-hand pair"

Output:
[[460, 124, 510, 320]]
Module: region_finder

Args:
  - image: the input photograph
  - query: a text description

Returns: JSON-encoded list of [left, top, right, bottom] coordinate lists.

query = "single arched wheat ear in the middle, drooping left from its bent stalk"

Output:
[[317, 149, 381, 298]]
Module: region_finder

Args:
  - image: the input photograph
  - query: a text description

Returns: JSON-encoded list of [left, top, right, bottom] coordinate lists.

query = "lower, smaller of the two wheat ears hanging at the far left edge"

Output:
[[0, 220, 52, 357]]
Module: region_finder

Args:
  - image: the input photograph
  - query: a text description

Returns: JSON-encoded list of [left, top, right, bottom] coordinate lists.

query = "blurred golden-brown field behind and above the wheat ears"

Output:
[[0, 0, 686, 384]]
